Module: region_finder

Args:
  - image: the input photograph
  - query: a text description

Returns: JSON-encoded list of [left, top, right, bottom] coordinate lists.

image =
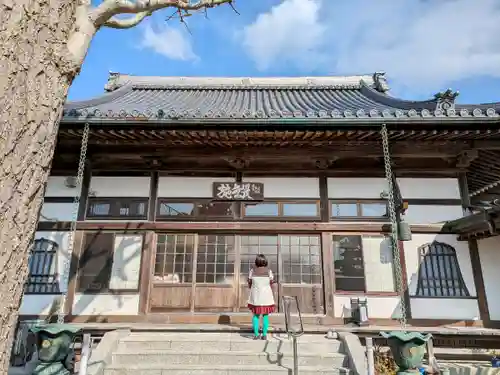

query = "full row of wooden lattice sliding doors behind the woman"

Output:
[[150, 234, 325, 314]]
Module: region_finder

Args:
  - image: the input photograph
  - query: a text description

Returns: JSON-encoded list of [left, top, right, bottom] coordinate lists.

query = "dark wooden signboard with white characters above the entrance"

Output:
[[213, 182, 264, 201]]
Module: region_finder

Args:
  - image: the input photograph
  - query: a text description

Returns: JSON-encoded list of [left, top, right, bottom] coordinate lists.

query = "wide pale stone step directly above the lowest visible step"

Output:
[[112, 350, 347, 368]]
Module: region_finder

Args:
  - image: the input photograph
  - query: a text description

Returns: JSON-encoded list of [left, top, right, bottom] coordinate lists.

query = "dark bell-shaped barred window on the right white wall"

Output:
[[415, 242, 470, 298]]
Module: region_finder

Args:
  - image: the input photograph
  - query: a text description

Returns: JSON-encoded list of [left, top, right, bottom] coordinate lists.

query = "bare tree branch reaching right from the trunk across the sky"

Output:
[[90, 0, 233, 29]]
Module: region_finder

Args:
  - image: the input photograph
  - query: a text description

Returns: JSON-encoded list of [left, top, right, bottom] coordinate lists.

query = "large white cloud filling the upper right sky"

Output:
[[241, 0, 500, 91]]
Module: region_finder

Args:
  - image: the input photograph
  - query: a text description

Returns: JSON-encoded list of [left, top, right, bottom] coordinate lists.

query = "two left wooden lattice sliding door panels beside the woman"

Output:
[[150, 234, 237, 313]]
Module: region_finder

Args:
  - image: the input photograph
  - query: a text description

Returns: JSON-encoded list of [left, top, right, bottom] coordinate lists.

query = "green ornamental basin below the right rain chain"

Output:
[[380, 331, 432, 375]]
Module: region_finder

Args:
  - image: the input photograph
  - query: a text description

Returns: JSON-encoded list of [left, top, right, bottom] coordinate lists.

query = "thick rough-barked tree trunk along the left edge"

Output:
[[0, 0, 78, 375]]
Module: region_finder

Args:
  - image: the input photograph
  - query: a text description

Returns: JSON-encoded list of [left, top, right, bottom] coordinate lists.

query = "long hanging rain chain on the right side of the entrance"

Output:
[[380, 124, 406, 328]]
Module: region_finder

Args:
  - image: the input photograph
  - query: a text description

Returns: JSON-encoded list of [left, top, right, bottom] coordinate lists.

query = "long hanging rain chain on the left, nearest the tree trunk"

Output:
[[57, 123, 90, 324]]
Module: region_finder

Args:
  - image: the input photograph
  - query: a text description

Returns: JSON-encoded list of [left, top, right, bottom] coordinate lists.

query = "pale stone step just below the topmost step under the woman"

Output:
[[118, 336, 342, 354]]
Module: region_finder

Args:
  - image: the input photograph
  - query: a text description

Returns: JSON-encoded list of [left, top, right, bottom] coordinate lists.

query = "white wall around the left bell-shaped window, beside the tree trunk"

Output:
[[19, 232, 69, 315]]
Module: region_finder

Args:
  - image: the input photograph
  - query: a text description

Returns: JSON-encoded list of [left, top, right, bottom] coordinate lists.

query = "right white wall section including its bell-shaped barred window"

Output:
[[392, 234, 479, 327]]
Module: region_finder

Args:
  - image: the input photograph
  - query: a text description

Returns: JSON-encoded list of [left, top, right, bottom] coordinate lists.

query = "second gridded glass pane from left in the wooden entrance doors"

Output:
[[196, 234, 235, 284]]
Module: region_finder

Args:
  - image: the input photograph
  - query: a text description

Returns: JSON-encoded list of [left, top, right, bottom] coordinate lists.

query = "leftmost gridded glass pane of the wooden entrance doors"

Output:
[[154, 234, 196, 284]]
